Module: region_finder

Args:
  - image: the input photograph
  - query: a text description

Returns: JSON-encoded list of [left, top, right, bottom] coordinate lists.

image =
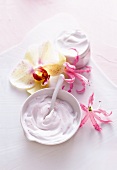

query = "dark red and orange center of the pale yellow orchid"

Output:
[[33, 67, 50, 84]]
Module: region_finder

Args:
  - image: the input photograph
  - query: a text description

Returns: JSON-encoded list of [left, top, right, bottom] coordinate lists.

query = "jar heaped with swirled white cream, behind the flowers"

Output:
[[55, 30, 90, 68]]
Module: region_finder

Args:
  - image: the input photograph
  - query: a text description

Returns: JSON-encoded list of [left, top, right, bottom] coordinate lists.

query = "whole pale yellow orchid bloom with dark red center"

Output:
[[10, 42, 66, 94]]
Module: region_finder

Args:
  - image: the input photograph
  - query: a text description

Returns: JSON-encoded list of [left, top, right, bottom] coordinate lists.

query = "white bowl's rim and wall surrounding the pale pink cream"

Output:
[[21, 88, 81, 145]]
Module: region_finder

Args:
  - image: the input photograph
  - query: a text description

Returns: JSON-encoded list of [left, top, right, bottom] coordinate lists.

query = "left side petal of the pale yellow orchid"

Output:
[[9, 60, 35, 89]]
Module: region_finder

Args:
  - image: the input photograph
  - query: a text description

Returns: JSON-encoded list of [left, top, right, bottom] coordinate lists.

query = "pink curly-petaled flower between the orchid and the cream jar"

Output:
[[64, 61, 91, 93]]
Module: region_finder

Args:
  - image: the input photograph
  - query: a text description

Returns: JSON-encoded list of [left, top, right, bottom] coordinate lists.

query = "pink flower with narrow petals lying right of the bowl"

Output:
[[80, 93, 112, 131]]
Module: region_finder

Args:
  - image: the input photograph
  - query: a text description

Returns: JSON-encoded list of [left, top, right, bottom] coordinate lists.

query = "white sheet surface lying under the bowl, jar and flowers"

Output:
[[0, 14, 117, 170]]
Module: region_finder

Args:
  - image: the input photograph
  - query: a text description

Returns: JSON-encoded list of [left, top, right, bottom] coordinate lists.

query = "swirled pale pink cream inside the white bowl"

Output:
[[22, 95, 78, 144]]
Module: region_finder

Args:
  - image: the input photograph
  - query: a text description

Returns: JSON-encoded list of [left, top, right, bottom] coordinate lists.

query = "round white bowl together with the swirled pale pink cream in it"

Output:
[[21, 88, 81, 145]]
